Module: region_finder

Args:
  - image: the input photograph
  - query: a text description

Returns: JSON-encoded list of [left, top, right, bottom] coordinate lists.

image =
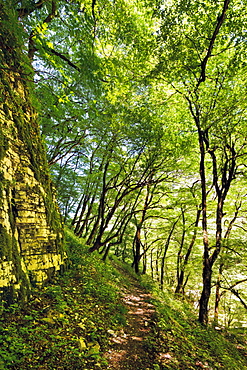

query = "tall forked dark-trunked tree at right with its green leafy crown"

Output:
[[153, 0, 246, 324]]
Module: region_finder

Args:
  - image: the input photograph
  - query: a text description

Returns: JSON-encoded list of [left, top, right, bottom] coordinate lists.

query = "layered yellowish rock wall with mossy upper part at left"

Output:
[[0, 5, 66, 301]]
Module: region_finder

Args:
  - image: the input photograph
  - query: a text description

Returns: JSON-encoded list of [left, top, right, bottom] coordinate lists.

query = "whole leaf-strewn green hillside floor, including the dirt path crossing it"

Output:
[[0, 233, 247, 370]]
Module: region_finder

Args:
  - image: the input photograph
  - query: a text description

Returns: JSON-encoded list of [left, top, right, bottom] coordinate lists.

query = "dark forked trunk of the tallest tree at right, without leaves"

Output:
[[185, 0, 231, 324]]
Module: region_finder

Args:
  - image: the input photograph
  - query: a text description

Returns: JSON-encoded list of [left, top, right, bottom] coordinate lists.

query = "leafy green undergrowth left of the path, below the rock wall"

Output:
[[0, 231, 125, 370]]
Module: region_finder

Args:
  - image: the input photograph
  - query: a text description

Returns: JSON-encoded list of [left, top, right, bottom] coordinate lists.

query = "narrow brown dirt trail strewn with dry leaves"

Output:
[[105, 271, 158, 370]]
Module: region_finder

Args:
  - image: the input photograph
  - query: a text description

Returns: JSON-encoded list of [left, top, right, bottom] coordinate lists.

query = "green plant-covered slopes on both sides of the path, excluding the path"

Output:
[[0, 233, 247, 370]]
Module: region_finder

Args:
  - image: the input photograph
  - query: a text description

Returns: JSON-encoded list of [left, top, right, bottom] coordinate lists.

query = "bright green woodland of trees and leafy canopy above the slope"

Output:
[[7, 0, 247, 325]]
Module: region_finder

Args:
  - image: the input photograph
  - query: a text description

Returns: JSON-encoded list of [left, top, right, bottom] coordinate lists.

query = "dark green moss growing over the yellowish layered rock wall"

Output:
[[0, 4, 63, 297]]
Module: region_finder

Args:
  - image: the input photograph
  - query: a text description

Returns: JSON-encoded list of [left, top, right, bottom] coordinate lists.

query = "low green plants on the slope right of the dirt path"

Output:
[[151, 292, 247, 370]]
